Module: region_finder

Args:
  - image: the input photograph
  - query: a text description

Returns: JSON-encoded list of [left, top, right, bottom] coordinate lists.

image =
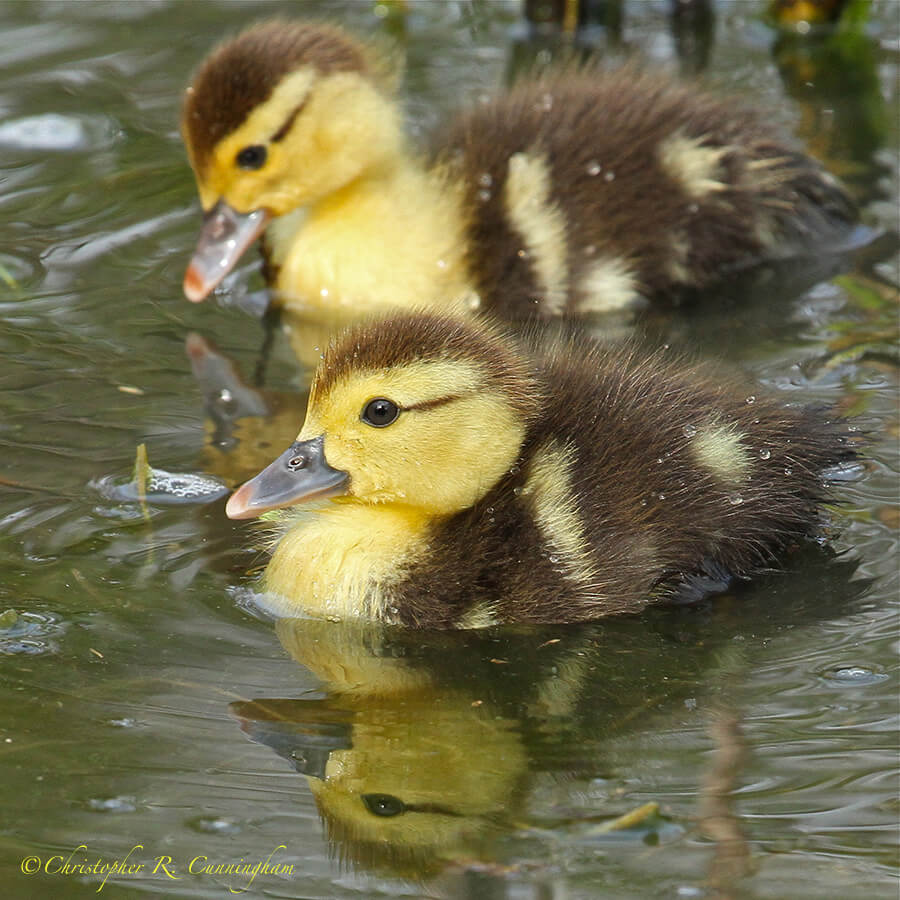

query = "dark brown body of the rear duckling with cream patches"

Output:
[[435, 66, 855, 314]]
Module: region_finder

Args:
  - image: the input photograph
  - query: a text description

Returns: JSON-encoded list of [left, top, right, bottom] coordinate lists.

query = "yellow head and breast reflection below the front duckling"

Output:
[[231, 619, 529, 877]]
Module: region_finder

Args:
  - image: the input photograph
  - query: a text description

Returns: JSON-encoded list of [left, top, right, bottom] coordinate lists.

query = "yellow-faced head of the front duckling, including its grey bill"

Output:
[[226, 314, 541, 519]]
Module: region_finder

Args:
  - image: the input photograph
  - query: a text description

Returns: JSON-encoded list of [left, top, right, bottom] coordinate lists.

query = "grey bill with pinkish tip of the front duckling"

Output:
[[225, 435, 350, 519]]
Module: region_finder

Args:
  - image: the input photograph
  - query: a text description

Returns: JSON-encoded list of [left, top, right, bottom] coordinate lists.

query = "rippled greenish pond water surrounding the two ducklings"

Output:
[[0, 0, 900, 900]]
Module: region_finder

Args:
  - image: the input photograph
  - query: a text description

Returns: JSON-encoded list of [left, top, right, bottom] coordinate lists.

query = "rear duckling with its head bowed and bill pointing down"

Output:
[[182, 21, 855, 317]]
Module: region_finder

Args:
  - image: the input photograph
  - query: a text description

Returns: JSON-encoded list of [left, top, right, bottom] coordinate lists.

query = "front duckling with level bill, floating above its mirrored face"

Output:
[[226, 313, 853, 628]]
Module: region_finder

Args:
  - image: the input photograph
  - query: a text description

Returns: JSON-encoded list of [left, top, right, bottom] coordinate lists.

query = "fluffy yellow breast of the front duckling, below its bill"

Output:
[[264, 499, 431, 621]]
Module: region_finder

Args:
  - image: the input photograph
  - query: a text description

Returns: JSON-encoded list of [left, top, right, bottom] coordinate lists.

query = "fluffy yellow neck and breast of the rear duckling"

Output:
[[266, 158, 477, 313]]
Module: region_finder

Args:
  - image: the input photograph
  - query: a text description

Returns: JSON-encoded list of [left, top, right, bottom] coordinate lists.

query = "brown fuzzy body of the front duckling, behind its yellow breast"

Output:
[[398, 339, 855, 627]]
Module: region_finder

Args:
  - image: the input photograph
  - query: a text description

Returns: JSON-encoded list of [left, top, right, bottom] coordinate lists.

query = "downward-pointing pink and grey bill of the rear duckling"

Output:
[[184, 200, 271, 303]]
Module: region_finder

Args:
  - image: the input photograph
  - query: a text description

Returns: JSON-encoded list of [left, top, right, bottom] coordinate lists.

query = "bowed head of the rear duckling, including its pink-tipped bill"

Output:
[[181, 21, 402, 301]]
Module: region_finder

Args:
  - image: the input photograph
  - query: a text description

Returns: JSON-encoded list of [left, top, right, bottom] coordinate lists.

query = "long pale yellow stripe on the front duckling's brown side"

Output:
[[522, 441, 596, 587]]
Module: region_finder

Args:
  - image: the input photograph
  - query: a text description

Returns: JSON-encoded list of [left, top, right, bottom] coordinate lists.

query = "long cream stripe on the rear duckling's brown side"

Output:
[[504, 153, 569, 312]]
